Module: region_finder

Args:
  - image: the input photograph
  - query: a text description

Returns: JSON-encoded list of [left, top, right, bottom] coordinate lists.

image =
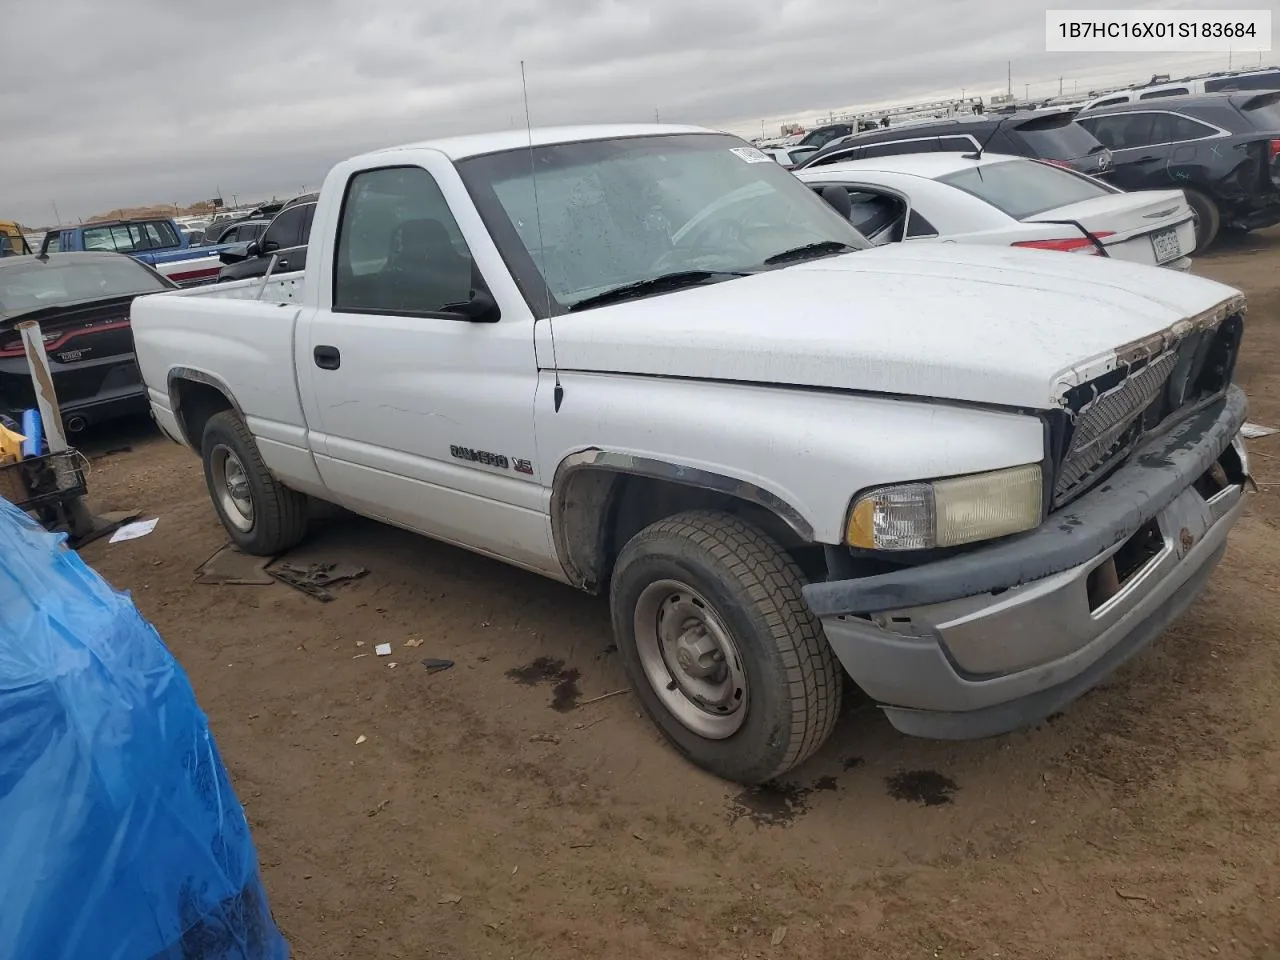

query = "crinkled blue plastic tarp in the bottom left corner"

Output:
[[0, 499, 288, 960]]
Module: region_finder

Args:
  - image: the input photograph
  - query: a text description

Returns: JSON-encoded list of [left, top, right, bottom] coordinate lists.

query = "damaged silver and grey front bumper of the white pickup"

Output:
[[805, 387, 1248, 739]]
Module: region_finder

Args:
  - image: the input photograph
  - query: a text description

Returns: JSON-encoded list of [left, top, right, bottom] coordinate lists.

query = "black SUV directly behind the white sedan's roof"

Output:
[[796, 110, 1111, 179]]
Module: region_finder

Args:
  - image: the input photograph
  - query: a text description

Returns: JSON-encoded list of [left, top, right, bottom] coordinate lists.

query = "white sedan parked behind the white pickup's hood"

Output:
[[796, 154, 1196, 270]]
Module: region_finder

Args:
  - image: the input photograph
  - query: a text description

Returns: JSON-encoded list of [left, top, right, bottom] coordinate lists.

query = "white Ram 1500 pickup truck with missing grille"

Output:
[[132, 125, 1249, 783]]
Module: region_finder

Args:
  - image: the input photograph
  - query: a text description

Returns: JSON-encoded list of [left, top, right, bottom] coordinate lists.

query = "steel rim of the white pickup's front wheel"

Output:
[[634, 580, 748, 740]]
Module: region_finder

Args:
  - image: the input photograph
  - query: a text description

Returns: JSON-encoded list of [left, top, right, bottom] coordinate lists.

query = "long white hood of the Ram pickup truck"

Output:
[[536, 243, 1243, 410]]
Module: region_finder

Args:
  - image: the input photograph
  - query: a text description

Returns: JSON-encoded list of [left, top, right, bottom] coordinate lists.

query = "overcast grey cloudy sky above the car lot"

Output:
[[0, 0, 1272, 225]]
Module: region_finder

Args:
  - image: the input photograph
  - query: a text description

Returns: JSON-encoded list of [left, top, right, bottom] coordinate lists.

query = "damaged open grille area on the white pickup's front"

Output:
[[1050, 314, 1244, 509]]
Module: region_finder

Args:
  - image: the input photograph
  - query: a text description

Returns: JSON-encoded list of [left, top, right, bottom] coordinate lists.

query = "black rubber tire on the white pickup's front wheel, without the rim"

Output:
[[609, 511, 844, 785]]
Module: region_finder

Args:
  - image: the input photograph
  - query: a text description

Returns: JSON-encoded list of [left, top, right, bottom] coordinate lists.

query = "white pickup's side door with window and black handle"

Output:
[[297, 159, 559, 572]]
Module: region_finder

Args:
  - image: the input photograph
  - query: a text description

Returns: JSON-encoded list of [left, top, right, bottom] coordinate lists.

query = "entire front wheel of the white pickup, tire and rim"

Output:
[[611, 511, 841, 785]]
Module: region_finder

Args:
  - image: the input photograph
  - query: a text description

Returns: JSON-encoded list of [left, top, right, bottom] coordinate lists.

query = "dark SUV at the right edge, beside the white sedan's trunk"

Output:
[[1076, 91, 1280, 250]]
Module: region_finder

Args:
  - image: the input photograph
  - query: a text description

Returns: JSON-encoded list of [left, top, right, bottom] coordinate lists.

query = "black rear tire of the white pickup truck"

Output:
[[200, 410, 307, 557]]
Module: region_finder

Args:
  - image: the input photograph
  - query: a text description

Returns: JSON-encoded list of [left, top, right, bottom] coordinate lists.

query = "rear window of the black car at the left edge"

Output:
[[0, 255, 170, 317]]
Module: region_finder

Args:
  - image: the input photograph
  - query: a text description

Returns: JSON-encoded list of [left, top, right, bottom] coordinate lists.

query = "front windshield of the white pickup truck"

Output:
[[458, 133, 868, 314]]
